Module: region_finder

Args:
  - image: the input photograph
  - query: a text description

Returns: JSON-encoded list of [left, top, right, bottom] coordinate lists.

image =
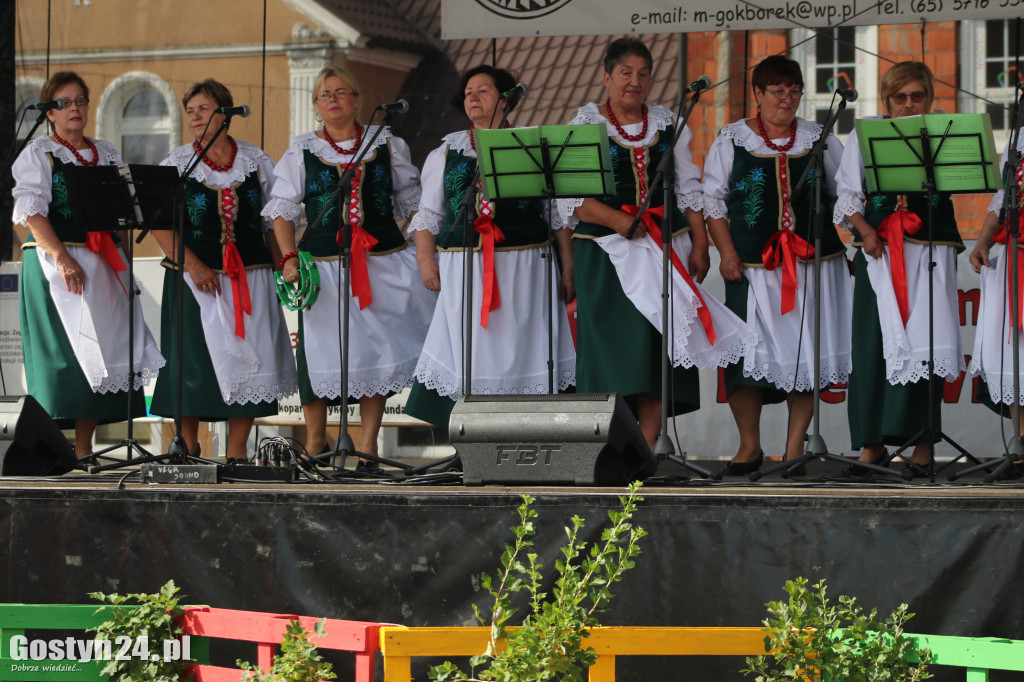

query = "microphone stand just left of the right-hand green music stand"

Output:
[[750, 97, 856, 480]]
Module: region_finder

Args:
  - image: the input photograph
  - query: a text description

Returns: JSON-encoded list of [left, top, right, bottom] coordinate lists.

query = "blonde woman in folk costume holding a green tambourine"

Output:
[[263, 67, 435, 472]]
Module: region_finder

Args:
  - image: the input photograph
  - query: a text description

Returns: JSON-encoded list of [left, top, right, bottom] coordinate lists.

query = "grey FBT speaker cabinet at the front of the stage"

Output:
[[449, 393, 657, 485]]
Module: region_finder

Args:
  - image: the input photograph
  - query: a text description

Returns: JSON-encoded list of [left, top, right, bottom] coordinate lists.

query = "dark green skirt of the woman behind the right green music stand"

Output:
[[847, 251, 945, 450]]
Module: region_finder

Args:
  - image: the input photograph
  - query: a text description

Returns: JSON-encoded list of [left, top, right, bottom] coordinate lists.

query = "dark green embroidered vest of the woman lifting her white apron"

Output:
[[574, 126, 690, 238]]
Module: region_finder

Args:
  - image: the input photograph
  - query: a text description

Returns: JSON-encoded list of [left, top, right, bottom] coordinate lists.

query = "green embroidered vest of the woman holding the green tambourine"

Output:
[[302, 144, 406, 258]]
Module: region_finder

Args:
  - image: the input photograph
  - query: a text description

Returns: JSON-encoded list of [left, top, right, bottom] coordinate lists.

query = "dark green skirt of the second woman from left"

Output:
[[151, 269, 278, 422]]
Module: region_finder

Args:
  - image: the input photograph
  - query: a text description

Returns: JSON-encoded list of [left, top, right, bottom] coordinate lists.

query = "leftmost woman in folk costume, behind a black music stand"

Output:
[[11, 71, 164, 457]]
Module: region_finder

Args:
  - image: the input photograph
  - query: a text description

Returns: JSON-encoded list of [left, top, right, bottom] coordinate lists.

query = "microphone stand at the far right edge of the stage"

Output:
[[948, 85, 1024, 483]]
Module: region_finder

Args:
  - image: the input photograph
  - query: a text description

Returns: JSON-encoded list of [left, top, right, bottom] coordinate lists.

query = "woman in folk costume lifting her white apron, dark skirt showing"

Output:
[[560, 38, 756, 449]]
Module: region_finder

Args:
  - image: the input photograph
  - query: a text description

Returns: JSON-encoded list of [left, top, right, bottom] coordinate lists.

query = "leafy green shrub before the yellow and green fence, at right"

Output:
[[742, 578, 932, 682]]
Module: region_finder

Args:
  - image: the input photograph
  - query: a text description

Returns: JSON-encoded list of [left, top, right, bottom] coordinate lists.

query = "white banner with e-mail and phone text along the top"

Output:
[[441, 0, 1024, 40]]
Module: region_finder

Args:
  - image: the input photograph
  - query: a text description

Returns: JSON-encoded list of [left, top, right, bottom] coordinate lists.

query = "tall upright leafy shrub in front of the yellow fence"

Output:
[[430, 483, 647, 682]]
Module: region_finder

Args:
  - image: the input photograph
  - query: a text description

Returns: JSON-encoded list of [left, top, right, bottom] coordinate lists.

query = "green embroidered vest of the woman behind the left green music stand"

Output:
[[437, 147, 548, 251]]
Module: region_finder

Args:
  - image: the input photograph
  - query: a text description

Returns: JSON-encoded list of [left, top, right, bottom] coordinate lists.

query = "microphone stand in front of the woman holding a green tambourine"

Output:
[[296, 106, 408, 469]]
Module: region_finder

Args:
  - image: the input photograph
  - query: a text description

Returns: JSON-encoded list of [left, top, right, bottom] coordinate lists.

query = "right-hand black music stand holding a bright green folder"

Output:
[[857, 114, 997, 482]]
